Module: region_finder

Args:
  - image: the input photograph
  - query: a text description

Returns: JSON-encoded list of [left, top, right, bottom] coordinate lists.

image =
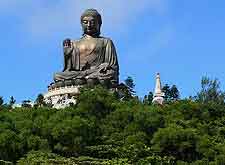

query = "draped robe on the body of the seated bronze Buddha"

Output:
[[54, 36, 119, 82]]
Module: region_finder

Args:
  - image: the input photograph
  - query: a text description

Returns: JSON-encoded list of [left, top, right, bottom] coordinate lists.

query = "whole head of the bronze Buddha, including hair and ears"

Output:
[[80, 9, 102, 36]]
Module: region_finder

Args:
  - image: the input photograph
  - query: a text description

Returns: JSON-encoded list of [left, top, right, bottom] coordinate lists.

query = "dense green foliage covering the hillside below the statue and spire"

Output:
[[0, 82, 225, 165]]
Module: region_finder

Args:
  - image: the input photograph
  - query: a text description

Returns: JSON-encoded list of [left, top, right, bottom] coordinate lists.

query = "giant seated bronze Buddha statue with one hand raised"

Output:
[[54, 9, 119, 86]]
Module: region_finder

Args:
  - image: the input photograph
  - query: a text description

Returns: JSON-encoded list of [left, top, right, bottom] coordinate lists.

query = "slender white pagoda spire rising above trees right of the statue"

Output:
[[152, 73, 164, 104]]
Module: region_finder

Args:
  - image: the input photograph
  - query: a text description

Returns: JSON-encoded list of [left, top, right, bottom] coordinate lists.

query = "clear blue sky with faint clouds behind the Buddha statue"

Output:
[[0, 0, 225, 102]]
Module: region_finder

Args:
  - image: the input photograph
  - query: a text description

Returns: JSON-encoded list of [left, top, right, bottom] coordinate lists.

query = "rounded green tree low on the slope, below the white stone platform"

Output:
[[51, 116, 95, 157]]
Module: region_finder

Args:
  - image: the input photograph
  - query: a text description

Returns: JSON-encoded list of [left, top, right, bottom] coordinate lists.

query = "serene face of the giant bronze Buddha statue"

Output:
[[81, 16, 100, 36]]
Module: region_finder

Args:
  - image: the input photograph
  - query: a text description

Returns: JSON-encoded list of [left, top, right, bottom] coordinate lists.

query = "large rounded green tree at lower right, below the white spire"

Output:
[[152, 126, 200, 162]]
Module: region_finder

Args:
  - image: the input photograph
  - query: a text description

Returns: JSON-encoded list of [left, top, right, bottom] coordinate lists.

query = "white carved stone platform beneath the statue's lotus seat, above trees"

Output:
[[44, 85, 81, 109]]
